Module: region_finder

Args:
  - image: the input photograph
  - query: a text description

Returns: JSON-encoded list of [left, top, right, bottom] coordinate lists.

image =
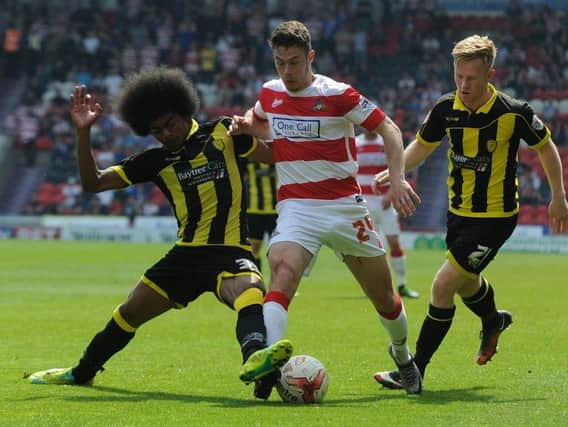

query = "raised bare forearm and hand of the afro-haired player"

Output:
[[69, 85, 126, 193]]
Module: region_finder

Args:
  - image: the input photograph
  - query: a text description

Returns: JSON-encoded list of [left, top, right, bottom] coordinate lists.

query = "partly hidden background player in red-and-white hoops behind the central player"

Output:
[[355, 128, 419, 298]]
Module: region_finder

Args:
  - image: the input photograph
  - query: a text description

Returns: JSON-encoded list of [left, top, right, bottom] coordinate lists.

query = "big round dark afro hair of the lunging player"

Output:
[[116, 66, 199, 136]]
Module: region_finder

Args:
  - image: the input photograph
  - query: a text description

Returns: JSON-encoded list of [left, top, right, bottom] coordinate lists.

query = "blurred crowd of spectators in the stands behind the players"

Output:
[[0, 0, 568, 222]]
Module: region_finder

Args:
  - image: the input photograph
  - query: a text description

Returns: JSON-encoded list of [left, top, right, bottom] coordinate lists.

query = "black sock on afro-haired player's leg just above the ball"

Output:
[[237, 304, 266, 363]]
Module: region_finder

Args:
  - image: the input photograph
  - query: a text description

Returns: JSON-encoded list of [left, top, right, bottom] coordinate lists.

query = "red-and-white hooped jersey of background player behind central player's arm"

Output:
[[355, 133, 389, 195]]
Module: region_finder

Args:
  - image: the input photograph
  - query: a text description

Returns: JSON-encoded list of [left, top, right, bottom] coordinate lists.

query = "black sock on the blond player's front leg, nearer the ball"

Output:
[[414, 304, 456, 377]]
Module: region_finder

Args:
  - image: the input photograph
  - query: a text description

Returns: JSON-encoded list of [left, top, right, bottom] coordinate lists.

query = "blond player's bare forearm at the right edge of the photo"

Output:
[[538, 140, 568, 233]]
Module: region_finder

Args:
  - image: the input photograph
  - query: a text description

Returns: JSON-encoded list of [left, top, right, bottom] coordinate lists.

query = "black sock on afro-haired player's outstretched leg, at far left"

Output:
[[72, 318, 134, 384]]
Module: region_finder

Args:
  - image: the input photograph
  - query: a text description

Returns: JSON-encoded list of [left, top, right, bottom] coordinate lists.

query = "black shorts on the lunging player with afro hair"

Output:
[[142, 245, 262, 308]]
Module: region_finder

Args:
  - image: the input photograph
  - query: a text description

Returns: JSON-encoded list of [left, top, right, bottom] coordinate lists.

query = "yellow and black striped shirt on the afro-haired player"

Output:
[[114, 117, 256, 249]]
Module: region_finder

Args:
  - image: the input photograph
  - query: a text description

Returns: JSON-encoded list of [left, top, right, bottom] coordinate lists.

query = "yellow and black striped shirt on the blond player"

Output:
[[416, 85, 550, 218]]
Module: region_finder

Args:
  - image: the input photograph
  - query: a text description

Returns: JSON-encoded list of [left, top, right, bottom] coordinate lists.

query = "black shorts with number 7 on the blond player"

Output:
[[446, 212, 517, 276]]
